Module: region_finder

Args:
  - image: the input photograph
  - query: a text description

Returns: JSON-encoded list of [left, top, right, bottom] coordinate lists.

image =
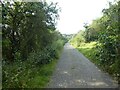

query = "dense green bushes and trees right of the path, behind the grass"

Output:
[[73, 1, 120, 82]]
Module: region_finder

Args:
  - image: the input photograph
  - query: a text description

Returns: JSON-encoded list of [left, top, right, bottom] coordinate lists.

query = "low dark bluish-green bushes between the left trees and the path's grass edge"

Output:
[[28, 40, 64, 66]]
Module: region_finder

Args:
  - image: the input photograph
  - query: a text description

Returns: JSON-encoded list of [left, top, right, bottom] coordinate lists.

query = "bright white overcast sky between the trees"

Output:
[[49, 0, 114, 34]]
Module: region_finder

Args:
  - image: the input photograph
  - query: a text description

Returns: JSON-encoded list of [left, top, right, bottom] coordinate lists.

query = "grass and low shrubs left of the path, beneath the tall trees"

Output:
[[2, 41, 64, 88]]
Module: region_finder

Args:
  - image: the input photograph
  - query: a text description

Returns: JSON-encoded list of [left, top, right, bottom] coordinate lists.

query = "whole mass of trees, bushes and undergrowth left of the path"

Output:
[[2, 1, 65, 88]]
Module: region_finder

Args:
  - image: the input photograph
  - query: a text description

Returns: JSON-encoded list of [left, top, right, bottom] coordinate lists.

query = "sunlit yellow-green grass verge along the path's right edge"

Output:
[[73, 42, 119, 82]]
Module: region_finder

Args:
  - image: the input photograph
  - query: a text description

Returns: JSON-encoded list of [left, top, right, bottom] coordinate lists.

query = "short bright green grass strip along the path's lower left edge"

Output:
[[28, 60, 57, 88]]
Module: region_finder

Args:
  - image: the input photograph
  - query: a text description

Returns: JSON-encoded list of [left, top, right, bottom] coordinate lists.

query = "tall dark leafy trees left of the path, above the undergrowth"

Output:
[[2, 1, 58, 62]]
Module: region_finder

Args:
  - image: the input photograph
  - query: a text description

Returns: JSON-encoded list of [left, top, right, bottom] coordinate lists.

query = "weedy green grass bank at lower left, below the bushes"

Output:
[[2, 44, 62, 88]]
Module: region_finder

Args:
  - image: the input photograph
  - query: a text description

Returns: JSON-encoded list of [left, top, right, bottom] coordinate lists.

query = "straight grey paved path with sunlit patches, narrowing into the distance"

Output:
[[48, 43, 118, 88]]
